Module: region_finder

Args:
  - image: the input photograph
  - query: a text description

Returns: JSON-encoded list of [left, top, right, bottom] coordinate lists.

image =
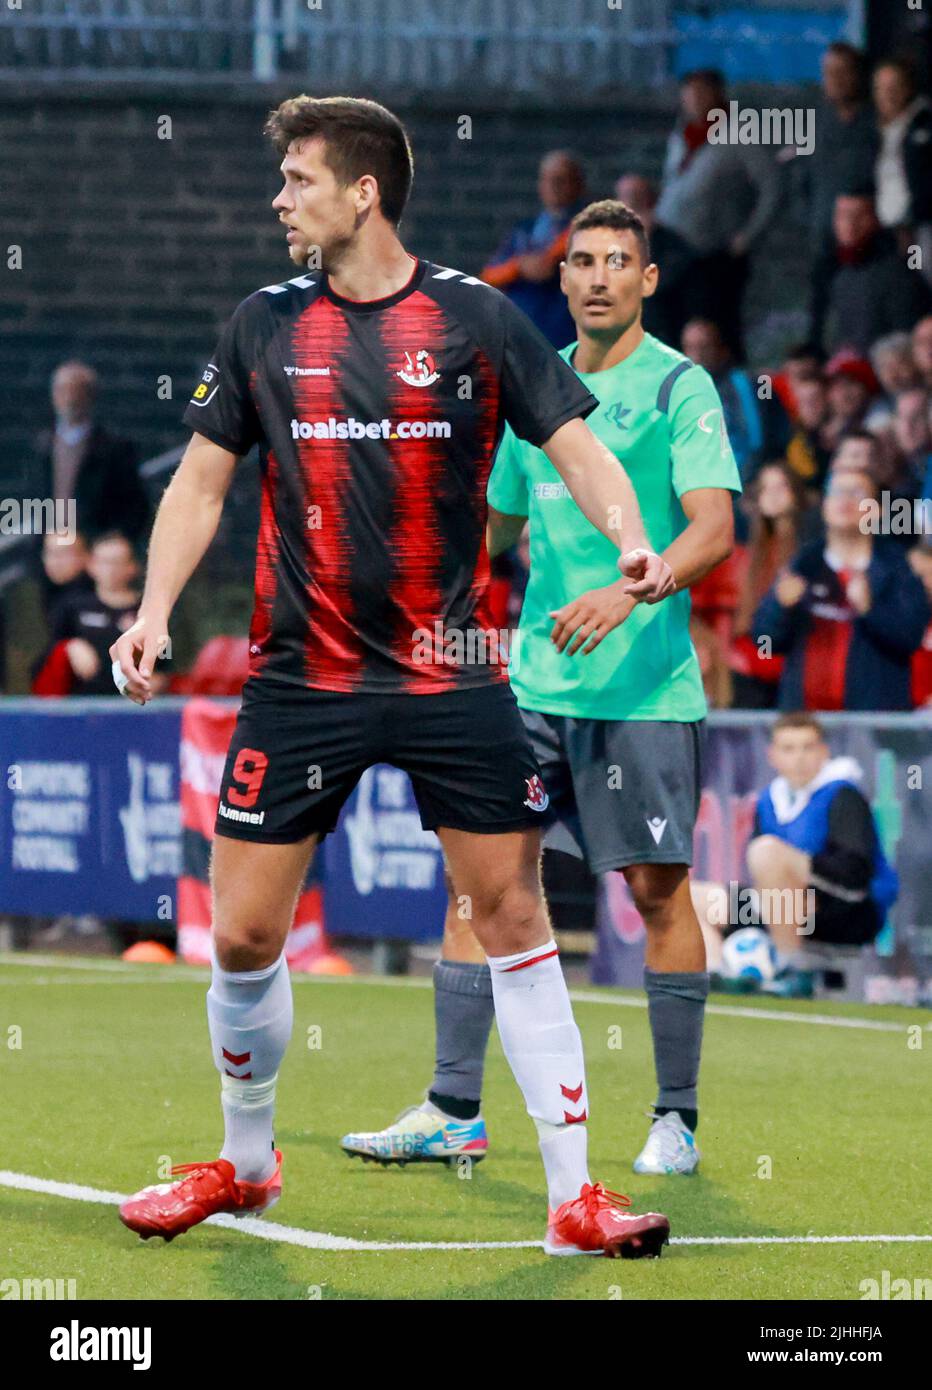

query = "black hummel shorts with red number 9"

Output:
[[214, 678, 547, 844]]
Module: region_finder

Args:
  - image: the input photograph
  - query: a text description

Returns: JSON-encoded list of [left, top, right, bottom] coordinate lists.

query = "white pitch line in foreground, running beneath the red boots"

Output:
[[0, 1170, 932, 1252]]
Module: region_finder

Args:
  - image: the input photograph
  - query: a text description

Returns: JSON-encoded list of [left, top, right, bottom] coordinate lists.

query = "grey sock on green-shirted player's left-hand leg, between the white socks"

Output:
[[431, 960, 494, 1102]]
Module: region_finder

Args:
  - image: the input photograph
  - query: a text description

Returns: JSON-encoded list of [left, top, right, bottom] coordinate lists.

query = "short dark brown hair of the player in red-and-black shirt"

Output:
[[265, 96, 414, 227]]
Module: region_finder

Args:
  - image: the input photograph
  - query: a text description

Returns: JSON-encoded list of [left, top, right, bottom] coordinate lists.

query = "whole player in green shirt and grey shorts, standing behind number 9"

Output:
[[343, 200, 740, 1173]]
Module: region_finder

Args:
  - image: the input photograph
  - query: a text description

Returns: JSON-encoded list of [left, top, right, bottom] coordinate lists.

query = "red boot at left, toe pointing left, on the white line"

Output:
[[119, 1150, 282, 1240]]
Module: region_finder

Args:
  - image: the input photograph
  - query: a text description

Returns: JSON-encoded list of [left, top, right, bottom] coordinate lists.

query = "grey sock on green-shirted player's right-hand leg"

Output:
[[644, 967, 708, 1115]]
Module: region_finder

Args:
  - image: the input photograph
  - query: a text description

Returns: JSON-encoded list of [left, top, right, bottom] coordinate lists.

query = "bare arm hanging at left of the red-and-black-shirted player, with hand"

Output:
[[110, 434, 238, 705]]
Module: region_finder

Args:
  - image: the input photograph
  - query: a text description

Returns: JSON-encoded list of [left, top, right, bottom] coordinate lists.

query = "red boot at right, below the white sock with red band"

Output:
[[543, 1183, 669, 1259]]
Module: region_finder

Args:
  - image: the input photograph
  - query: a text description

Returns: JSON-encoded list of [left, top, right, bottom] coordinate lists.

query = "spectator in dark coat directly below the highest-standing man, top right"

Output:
[[811, 190, 932, 356]]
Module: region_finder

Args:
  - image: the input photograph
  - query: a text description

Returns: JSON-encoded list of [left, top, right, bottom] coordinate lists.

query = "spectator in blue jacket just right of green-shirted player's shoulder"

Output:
[[682, 318, 789, 482]]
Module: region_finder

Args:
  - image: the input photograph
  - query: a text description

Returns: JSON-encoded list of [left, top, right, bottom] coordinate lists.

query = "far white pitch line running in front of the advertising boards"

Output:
[[0, 955, 932, 1033]]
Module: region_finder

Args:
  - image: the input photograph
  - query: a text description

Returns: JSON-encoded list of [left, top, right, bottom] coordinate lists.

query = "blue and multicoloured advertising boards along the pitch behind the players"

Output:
[[0, 699, 932, 974]]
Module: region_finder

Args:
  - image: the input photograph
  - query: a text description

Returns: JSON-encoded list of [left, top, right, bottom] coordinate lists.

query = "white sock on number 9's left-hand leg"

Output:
[[207, 955, 293, 1183]]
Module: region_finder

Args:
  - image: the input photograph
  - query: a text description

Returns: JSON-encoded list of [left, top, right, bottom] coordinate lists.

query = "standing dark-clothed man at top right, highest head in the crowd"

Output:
[[799, 43, 879, 254]]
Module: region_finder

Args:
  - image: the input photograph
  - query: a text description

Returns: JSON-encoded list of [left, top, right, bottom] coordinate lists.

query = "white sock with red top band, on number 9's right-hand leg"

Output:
[[488, 941, 589, 1211]]
